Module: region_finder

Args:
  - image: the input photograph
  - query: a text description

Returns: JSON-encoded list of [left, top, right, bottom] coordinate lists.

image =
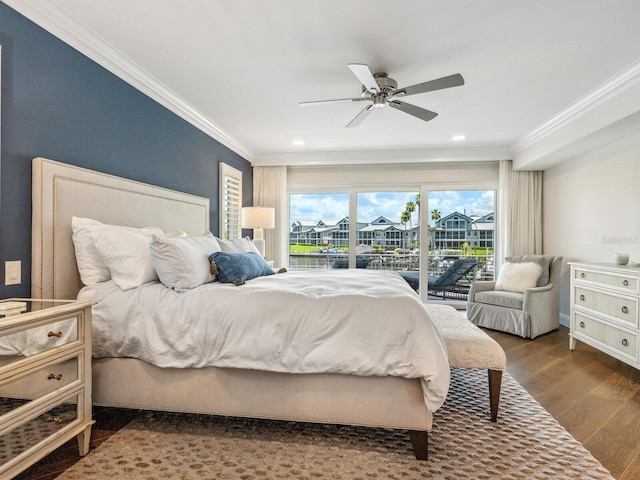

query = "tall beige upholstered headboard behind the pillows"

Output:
[[31, 158, 213, 299]]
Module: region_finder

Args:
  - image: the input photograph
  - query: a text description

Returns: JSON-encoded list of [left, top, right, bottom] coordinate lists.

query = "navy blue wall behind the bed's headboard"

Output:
[[0, 3, 253, 298]]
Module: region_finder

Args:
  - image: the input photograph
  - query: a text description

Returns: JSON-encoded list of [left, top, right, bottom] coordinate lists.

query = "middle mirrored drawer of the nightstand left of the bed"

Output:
[[0, 353, 82, 415]]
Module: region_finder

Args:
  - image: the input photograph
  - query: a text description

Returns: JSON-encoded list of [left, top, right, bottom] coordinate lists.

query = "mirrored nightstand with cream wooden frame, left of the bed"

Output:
[[0, 299, 93, 478]]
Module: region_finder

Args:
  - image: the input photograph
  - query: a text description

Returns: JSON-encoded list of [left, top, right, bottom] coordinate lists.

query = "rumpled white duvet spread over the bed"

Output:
[[79, 269, 449, 412]]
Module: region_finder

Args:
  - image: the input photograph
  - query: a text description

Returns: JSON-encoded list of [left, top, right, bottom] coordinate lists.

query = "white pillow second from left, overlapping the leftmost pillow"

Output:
[[91, 228, 158, 290]]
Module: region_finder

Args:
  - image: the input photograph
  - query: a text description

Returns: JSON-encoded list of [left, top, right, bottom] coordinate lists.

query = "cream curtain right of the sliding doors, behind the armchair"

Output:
[[496, 160, 543, 266]]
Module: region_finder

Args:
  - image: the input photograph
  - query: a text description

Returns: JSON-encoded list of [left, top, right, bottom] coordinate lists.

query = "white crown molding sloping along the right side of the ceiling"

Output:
[[512, 59, 640, 155]]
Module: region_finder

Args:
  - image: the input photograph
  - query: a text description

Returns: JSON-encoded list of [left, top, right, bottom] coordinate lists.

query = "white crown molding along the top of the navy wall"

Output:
[[2, 0, 254, 161]]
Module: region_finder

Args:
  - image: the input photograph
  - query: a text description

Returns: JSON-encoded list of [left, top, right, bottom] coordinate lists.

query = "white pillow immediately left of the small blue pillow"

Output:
[[151, 232, 220, 292]]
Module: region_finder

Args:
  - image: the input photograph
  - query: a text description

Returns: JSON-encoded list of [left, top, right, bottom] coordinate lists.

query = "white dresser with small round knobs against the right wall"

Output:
[[569, 263, 640, 368]]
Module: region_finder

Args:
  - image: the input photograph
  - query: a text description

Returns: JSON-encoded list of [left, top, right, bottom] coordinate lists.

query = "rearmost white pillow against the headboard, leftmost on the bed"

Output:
[[71, 217, 162, 285]]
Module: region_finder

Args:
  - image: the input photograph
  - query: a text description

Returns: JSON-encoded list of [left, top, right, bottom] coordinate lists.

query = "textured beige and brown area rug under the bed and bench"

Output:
[[52, 369, 613, 480]]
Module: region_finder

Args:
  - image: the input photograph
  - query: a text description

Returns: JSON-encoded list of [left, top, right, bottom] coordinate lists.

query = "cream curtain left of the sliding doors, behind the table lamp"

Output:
[[253, 167, 289, 267]]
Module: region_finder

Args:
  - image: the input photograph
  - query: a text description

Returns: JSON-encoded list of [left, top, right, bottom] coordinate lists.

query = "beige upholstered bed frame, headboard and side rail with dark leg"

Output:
[[31, 158, 433, 460]]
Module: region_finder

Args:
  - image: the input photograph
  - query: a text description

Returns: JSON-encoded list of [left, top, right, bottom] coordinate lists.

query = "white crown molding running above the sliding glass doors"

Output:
[[252, 146, 512, 167]]
